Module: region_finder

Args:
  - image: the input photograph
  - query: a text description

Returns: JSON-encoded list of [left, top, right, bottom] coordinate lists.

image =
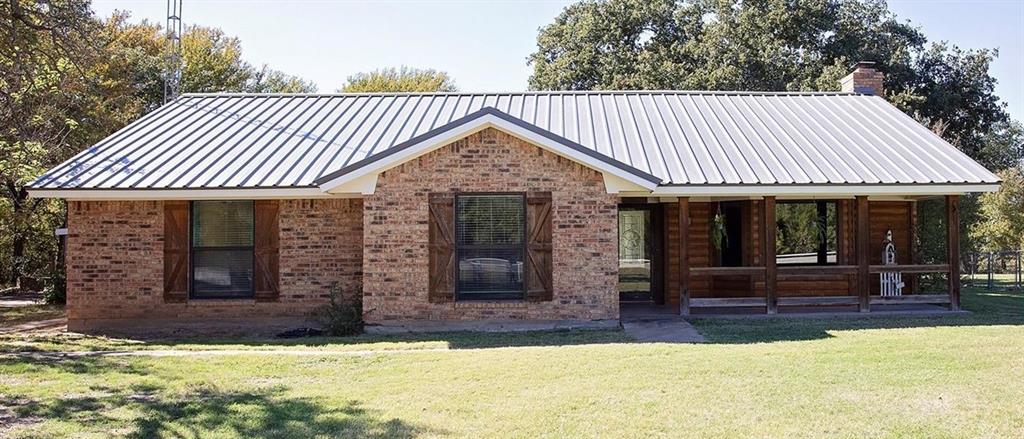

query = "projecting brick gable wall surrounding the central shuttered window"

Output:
[[364, 129, 618, 322]]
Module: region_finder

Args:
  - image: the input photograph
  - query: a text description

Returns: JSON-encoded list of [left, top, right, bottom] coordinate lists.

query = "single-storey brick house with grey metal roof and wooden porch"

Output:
[[30, 63, 998, 331]]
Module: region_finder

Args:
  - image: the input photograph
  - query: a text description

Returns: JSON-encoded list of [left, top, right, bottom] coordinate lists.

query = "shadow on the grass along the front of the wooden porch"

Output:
[[689, 289, 1024, 344]]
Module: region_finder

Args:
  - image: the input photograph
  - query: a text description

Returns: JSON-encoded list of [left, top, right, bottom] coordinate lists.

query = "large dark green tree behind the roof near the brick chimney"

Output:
[[529, 0, 1021, 169]]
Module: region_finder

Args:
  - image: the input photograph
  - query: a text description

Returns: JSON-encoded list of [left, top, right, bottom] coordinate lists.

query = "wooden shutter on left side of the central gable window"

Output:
[[428, 192, 456, 303]]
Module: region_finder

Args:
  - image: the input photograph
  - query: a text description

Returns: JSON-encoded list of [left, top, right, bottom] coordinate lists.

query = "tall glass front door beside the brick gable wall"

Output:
[[618, 207, 654, 302]]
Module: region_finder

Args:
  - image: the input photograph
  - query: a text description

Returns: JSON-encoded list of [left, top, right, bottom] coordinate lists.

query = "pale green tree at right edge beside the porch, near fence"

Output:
[[971, 167, 1024, 251]]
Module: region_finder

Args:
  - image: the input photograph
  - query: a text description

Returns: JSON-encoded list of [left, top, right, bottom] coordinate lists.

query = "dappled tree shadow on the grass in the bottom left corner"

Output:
[[0, 385, 443, 438]]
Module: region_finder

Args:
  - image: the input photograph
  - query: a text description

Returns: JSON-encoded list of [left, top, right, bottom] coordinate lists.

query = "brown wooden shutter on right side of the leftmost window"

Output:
[[253, 200, 281, 302]]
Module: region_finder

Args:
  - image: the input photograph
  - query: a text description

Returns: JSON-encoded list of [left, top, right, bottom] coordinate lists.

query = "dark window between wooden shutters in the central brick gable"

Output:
[[456, 194, 526, 300]]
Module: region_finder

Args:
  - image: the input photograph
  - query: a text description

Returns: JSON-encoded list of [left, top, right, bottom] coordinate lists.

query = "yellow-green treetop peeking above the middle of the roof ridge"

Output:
[[340, 67, 459, 93]]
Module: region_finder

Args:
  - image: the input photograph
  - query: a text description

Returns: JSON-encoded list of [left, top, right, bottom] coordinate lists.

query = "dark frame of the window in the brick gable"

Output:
[[453, 192, 529, 302]]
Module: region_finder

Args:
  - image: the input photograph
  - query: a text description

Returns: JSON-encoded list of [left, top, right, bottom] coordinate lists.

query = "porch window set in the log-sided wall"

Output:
[[775, 202, 837, 265]]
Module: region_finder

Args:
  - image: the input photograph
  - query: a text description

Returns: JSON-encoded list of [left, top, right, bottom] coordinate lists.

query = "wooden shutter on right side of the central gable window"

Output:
[[526, 192, 554, 302]]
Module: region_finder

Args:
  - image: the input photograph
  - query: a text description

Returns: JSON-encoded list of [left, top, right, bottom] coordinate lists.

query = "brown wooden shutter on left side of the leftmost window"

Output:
[[164, 202, 188, 303]]
